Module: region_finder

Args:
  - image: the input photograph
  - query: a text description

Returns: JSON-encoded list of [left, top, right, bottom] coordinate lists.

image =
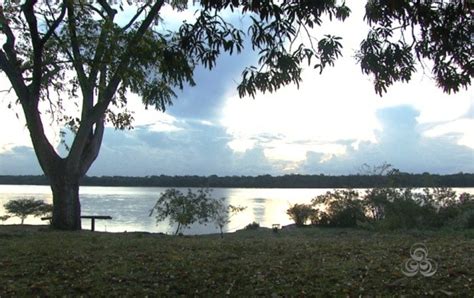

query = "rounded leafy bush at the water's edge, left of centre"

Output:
[[150, 188, 216, 235]]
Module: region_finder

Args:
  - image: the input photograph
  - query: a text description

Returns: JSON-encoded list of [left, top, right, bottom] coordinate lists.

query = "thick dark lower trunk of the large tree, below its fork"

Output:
[[50, 176, 81, 230]]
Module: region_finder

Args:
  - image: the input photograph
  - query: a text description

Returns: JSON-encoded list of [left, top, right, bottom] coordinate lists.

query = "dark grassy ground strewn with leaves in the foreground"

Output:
[[0, 226, 474, 297]]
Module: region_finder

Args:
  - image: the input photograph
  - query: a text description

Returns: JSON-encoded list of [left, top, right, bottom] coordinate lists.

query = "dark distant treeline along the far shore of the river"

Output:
[[0, 172, 474, 188]]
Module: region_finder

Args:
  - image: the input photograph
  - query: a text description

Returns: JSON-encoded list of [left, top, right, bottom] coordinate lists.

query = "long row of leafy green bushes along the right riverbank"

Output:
[[287, 188, 474, 230]]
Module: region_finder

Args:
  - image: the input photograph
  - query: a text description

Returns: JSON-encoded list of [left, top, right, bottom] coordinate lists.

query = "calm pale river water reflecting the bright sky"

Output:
[[0, 185, 474, 234]]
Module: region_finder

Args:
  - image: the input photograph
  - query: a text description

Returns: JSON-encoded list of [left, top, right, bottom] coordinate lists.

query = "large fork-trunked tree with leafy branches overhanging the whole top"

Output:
[[0, 0, 472, 230]]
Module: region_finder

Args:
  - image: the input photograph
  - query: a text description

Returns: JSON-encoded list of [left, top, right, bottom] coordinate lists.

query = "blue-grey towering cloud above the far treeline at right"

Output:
[[300, 106, 474, 174]]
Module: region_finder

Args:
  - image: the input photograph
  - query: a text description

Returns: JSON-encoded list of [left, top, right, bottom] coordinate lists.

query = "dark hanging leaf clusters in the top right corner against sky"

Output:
[[357, 0, 474, 95]]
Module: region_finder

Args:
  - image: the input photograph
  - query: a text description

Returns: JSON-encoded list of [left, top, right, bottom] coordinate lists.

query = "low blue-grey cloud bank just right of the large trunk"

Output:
[[88, 121, 277, 176]]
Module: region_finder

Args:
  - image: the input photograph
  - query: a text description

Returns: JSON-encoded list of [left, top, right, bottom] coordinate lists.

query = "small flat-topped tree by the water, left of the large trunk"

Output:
[[3, 199, 52, 224]]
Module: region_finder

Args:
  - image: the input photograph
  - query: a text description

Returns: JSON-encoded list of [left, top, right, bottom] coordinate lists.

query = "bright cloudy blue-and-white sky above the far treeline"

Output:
[[0, 0, 474, 176]]
